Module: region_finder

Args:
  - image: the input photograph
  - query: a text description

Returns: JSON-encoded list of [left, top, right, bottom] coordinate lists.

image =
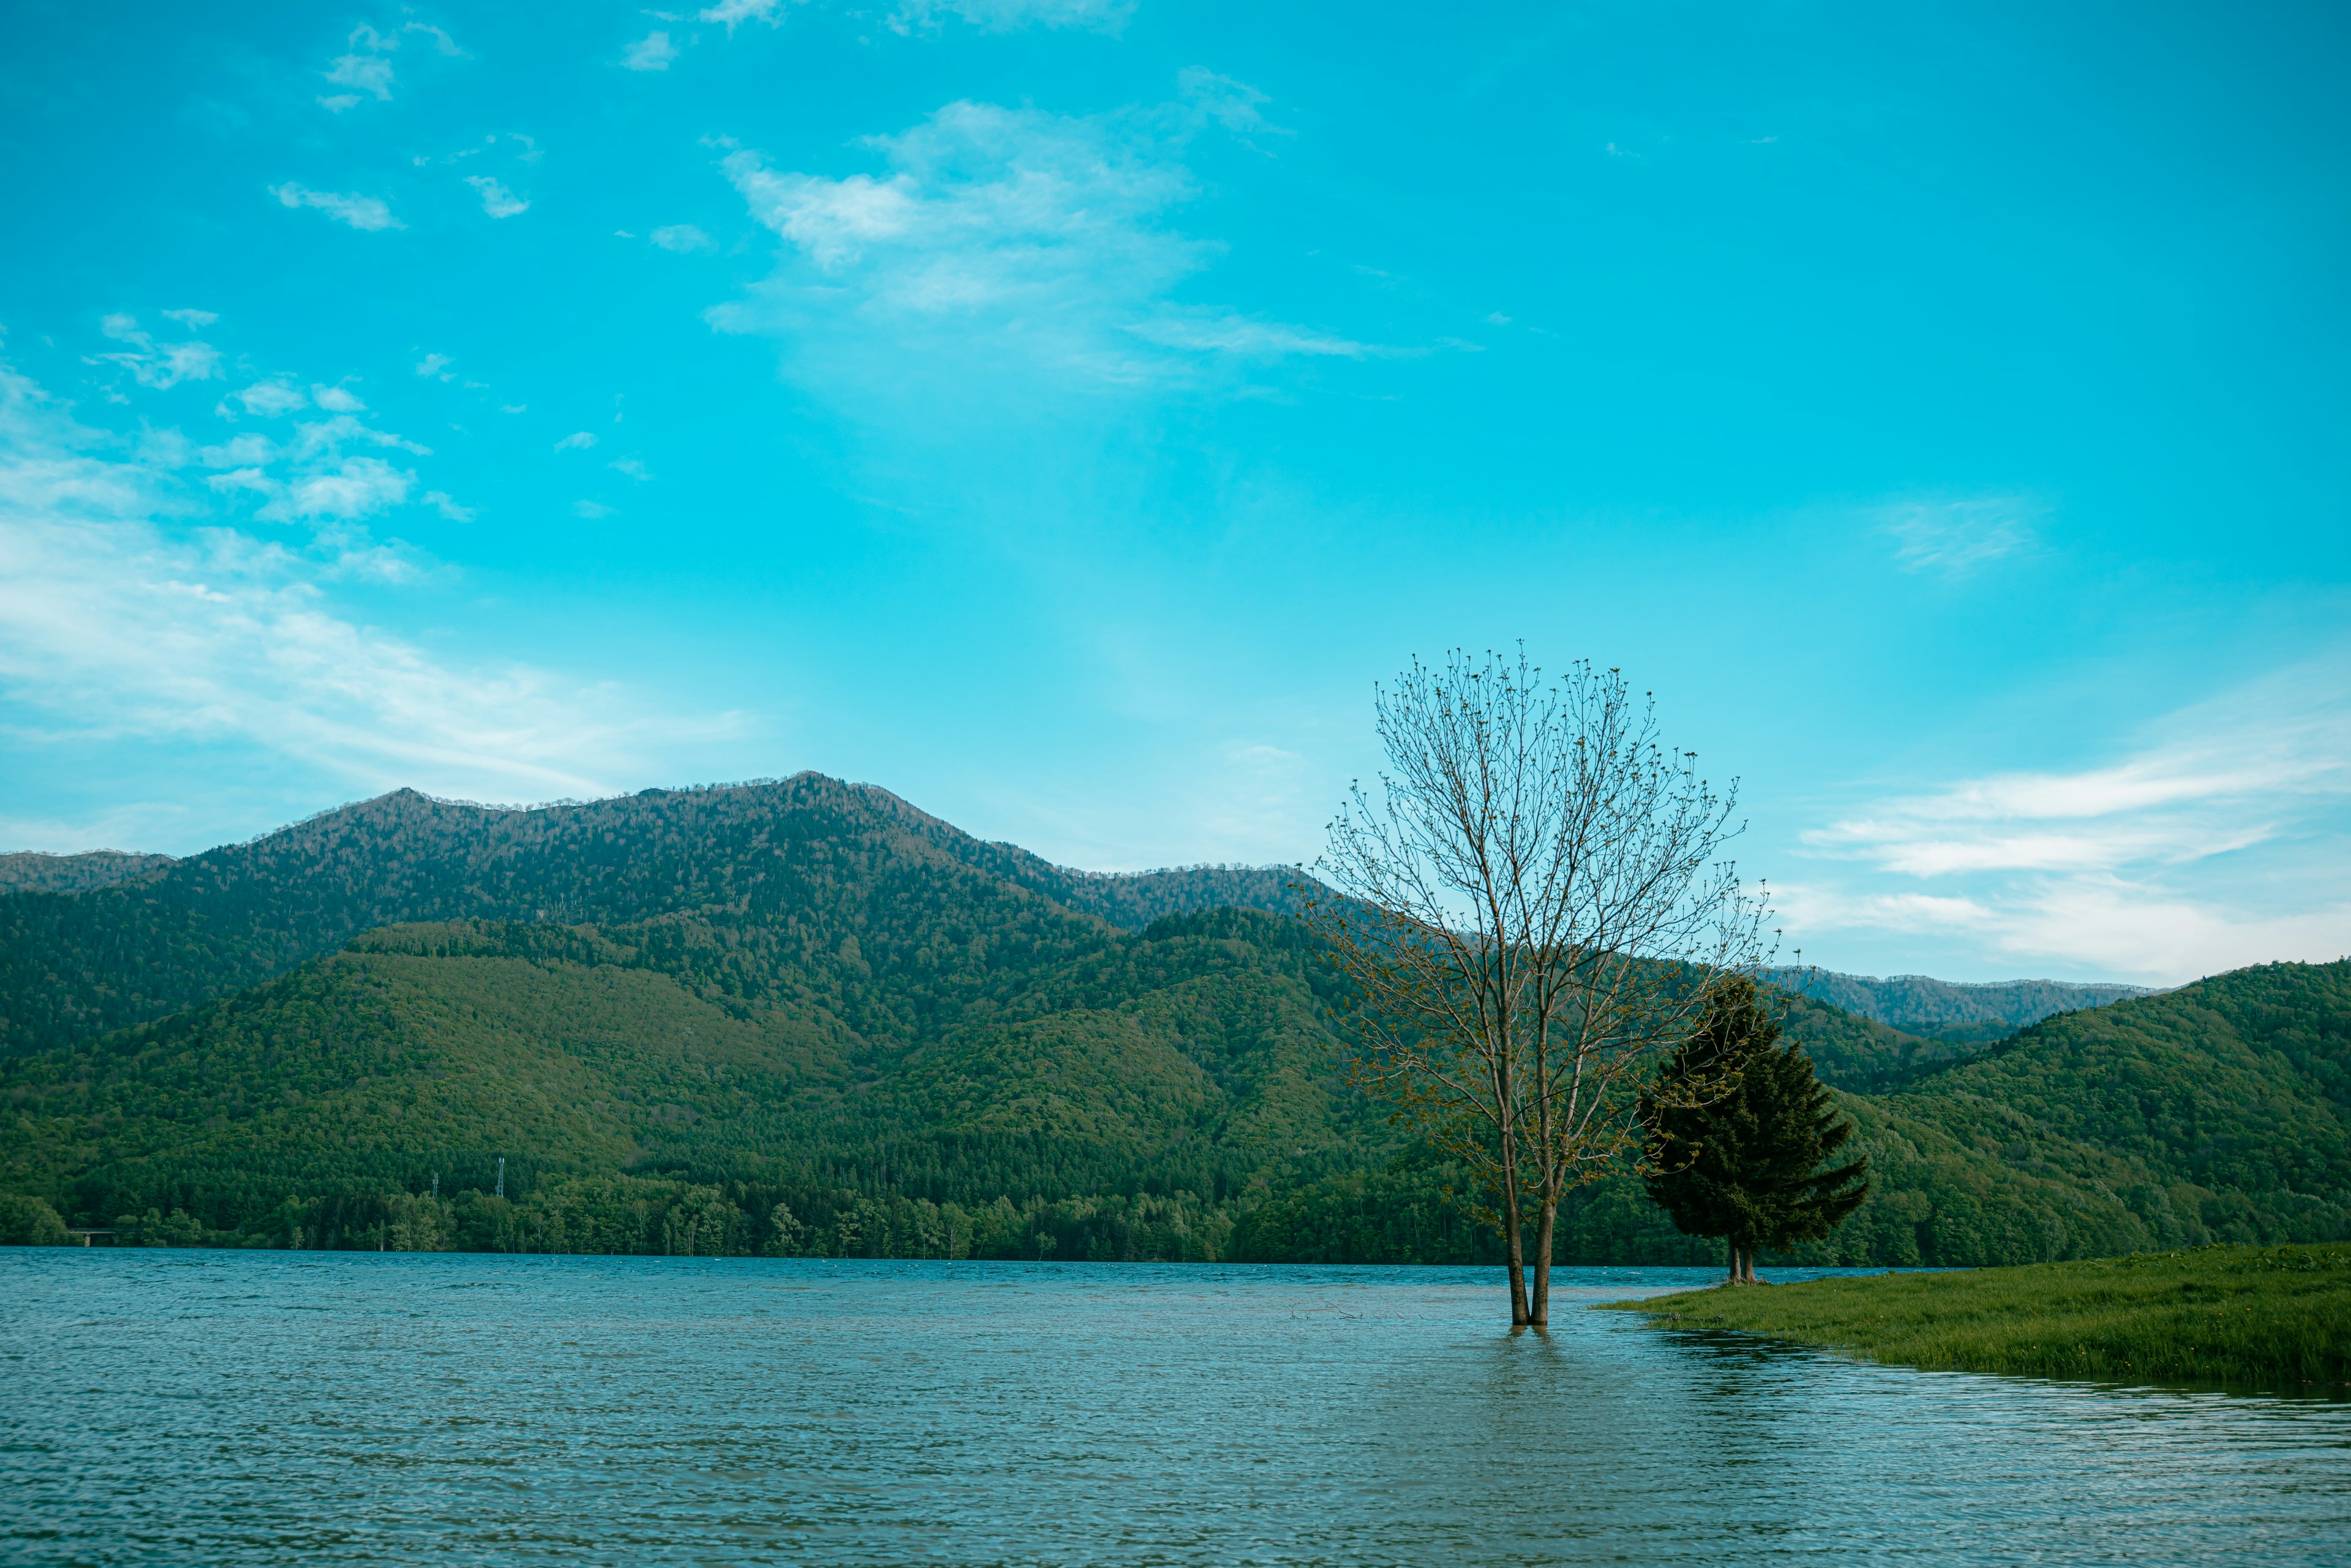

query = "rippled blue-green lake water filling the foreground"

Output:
[[0, 1248, 2351, 1568]]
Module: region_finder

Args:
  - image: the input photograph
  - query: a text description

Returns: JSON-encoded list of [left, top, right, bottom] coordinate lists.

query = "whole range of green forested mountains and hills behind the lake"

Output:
[[0, 776, 2351, 1262]]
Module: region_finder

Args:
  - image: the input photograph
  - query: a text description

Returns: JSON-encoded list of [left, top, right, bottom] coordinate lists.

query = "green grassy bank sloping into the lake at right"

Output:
[[1610, 1244, 2351, 1389]]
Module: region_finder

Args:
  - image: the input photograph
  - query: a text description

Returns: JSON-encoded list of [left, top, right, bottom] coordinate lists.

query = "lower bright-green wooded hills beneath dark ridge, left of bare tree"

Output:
[[0, 912, 1392, 1229]]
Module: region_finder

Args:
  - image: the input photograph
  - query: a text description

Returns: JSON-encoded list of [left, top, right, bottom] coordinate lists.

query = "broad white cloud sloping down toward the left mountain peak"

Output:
[[0, 367, 741, 799]]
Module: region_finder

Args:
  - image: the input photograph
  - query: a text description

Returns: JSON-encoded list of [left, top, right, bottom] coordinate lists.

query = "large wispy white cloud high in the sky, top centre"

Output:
[[710, 85, 1373, 392]]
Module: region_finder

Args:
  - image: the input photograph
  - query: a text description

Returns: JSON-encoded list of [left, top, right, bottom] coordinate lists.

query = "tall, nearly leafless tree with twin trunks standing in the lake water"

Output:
[[1307, 649, 1766, 1326]]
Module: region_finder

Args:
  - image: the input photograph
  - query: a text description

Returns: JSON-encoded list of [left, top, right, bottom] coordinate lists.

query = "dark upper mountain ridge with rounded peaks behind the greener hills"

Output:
[[0, 773, 1291, 1056]]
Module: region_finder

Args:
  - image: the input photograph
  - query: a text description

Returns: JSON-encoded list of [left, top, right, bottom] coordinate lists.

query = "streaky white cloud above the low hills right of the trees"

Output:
[[1780, 649, 2351, 980]]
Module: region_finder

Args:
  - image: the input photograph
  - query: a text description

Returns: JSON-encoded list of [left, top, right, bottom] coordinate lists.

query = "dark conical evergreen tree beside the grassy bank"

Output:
[[1641, 978, 1869, 1283]]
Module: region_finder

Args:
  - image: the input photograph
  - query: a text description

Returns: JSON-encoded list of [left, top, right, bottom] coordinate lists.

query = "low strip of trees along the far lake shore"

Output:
[[23, 1142, 2342, 1267]]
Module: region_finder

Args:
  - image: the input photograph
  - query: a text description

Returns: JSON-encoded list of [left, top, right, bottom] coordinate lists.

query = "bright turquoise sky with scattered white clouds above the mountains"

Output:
[[0, 0, 2351, 983]]
